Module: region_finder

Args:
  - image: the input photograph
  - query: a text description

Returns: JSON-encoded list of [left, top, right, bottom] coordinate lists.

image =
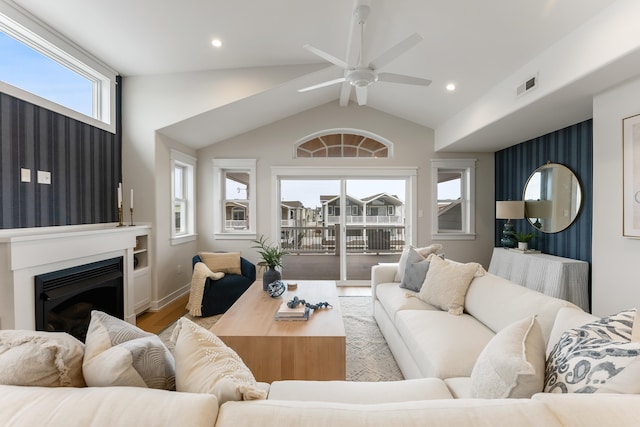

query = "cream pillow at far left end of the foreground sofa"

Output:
[[0, 330, 85, 387]]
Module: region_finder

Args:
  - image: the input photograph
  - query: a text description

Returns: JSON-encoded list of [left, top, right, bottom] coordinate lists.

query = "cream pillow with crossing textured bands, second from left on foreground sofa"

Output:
[[82, 310, 175, 390]]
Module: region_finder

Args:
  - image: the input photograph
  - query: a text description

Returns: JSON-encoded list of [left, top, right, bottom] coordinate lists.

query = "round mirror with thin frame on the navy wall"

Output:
[[522, 163, 582, 233]]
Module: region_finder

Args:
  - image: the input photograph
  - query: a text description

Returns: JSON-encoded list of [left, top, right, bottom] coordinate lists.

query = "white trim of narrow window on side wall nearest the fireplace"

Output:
[[169, 150, 198, 246]]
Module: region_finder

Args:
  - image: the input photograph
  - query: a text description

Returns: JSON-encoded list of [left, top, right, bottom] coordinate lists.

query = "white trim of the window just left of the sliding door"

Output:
[[213, 159, 257, 240]]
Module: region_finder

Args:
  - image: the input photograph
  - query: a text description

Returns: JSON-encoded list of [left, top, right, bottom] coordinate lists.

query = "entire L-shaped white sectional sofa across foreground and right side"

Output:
[[0, 256, 640, 427]]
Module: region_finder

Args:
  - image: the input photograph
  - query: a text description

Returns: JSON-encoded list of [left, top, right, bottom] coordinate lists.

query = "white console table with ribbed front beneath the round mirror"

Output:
[[489, 248, 589, 312]]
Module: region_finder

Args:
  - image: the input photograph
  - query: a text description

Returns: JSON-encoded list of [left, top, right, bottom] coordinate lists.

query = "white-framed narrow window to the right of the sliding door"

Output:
[[432, 159, 475, 240]]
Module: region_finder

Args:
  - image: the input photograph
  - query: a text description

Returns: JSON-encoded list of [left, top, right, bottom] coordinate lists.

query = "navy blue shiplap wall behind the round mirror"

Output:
[[495, 120, 593, 263]]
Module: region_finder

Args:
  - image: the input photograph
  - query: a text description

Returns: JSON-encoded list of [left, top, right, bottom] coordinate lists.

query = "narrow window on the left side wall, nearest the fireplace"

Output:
[[171, 150, 196, 244]]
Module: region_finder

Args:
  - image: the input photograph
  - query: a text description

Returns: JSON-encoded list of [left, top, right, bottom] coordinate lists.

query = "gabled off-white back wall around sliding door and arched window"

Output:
[[198, 101, 494, 266]]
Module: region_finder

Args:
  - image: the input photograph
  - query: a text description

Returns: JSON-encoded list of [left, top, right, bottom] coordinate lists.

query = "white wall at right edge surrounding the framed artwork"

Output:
[[592, 75, 640, 316]]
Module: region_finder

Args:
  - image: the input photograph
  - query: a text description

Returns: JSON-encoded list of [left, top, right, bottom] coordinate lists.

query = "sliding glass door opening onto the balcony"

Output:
[[277, 177, 409, 281]]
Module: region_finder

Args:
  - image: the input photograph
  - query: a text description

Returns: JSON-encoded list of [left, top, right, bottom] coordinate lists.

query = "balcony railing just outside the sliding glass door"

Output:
[[280, 225, 405, 254]]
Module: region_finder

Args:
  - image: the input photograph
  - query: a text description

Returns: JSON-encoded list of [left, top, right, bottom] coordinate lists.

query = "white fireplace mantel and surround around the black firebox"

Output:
[[0, 223, 151, 330]]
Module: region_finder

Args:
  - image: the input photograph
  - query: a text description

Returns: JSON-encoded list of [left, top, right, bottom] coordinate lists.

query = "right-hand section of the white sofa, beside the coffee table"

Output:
[[371, 264, 580, 379]]
